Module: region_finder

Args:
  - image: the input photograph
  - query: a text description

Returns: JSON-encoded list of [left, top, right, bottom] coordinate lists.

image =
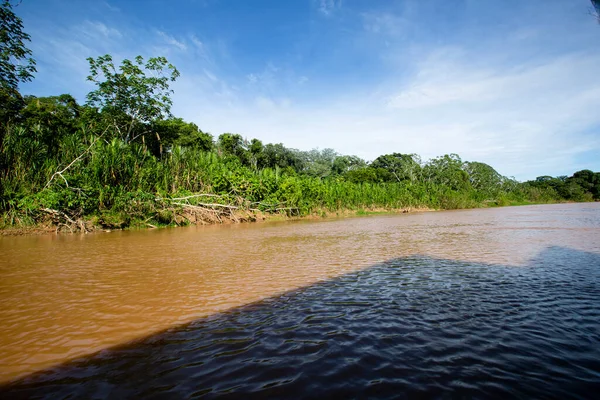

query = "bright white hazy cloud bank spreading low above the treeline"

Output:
[[171, 44, 600, 179]]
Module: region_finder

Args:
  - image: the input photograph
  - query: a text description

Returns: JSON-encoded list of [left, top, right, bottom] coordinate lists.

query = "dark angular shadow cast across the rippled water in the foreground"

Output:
[[0, 247, 600, 399]]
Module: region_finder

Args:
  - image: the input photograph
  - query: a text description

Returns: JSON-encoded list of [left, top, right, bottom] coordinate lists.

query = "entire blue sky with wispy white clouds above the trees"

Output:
[[14, 0, 600, 180]]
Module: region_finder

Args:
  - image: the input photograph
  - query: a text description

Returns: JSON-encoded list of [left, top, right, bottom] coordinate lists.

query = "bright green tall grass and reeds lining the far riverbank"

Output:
[[0, 125, 558, 230]]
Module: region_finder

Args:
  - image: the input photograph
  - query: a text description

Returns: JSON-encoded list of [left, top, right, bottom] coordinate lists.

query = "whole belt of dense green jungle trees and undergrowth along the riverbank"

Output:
[[0, 1, 600, 231]]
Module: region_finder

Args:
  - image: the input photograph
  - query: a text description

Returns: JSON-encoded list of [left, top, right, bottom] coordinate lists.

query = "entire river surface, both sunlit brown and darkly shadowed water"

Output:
[[0, 203, 600, 398]]
